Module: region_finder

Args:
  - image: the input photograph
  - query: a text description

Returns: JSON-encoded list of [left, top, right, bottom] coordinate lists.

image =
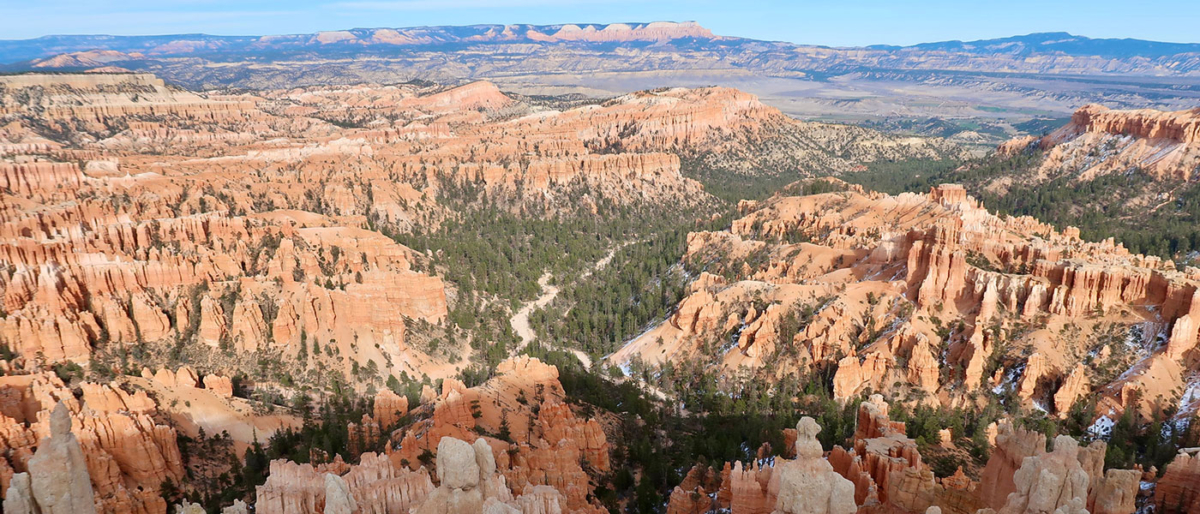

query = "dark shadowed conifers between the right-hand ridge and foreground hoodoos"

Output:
[[529, 336, 1200, 513]]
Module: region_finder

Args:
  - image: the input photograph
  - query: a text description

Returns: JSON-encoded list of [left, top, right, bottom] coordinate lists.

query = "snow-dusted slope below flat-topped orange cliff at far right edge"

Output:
[[926, 106, 1200, 262]]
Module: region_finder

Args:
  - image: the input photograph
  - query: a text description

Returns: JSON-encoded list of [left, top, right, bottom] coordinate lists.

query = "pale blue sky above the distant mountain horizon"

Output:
[[0, 0, 1200, 46]]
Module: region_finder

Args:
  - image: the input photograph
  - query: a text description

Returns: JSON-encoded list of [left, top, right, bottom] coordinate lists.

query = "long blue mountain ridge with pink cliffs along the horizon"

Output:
[[0, 22, 1200, 64]]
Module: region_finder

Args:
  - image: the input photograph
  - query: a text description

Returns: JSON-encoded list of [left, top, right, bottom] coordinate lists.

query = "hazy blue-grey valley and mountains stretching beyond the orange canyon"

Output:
[[7, 22, 1200, 151]]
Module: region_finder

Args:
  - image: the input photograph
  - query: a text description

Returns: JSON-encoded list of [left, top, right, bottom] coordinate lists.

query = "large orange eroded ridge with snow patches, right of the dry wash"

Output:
[[610, 181, 1200, 425]]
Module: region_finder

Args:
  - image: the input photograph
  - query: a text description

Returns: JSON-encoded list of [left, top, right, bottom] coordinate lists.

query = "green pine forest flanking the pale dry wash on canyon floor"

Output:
[[379, 171, 719, 372]]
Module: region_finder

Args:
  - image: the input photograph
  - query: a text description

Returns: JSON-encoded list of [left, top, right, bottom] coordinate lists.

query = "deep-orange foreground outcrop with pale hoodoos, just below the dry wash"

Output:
[[256, 358, 611, 514]]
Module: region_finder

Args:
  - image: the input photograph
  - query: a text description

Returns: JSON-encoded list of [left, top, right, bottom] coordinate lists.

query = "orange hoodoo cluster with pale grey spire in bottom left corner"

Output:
[[0, 373, 185, 513]]
